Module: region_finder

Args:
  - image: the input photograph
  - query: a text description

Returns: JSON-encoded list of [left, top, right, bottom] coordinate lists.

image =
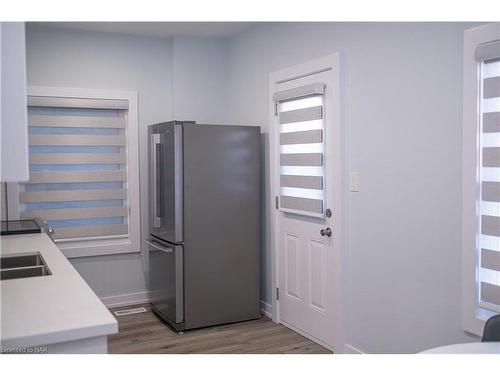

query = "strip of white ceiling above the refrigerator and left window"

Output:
[[30, 22, 255, 38]]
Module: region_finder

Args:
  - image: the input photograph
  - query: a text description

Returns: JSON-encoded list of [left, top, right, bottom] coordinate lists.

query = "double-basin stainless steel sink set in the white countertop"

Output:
[[0, 252, 51, 280]]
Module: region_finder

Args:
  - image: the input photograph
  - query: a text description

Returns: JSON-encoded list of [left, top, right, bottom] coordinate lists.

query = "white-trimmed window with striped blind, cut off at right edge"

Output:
[[463, 24, 500, 335]]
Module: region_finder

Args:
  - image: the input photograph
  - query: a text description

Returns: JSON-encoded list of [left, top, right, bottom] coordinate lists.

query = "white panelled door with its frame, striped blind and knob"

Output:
[[270, 55, 342, 351]]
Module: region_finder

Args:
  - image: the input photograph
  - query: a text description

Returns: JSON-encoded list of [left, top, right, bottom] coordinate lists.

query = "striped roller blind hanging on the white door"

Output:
[[274, 83, 325, 217]]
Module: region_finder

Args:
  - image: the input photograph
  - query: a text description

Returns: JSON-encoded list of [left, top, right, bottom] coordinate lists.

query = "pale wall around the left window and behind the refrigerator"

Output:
[[26, 25, 227, 302]]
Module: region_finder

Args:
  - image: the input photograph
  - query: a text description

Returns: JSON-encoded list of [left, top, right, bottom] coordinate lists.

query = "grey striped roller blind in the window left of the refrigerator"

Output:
[[19, 97, 128, 241]]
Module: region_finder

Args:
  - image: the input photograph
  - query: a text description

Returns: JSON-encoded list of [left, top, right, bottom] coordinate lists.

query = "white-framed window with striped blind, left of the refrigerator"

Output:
[[7, 88, 139, 257]]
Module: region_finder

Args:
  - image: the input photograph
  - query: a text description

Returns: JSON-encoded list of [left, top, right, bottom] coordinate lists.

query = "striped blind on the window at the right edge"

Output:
[[476, 47, 500, 312]]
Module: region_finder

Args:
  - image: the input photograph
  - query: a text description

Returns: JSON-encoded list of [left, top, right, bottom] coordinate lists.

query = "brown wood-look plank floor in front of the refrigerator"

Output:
[[108, 305, 331, 354]]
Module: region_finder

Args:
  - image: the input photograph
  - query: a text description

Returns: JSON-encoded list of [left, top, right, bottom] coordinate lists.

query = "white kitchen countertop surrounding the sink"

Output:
[[0, 233, 118, 348]]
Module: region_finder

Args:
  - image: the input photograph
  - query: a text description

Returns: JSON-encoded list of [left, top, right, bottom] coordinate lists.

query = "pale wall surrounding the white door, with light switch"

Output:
[[228, 23, 475, 353]]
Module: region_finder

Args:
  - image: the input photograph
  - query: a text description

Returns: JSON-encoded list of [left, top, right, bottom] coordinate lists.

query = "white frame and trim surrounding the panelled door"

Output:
[[268, 53, 345, 353]]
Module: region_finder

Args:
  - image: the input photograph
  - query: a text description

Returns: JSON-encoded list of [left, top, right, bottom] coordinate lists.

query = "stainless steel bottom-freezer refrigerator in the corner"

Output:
[[147, 121, 261, 331]]
